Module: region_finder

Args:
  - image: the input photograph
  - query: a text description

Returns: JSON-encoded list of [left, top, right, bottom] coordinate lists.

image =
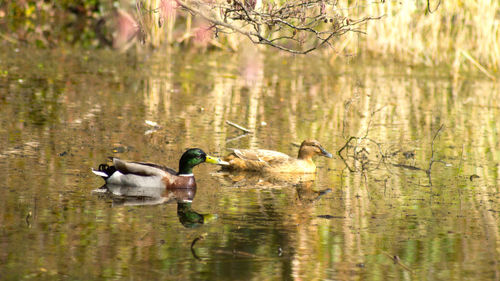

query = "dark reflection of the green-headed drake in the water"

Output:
[[93, 184, 217, 228]]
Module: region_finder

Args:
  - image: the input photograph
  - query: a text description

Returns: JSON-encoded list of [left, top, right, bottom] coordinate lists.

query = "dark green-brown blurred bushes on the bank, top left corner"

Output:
[[0, 0, 114, 48]]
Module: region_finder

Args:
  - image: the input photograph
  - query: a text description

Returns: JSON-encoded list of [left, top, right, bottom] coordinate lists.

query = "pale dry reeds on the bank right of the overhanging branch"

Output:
[[340, 0, 500, 78]]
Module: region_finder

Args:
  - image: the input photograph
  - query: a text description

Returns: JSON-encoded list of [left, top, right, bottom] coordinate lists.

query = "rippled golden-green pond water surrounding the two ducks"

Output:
[[0, 44, 500, 280]]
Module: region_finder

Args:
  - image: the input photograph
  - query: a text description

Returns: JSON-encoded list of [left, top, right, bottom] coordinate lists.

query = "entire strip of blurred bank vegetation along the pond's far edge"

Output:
[[0, 0, 500, 75]]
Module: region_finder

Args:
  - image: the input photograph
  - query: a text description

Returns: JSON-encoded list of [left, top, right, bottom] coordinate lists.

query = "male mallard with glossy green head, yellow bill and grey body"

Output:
[[92, 148, 228, 188]]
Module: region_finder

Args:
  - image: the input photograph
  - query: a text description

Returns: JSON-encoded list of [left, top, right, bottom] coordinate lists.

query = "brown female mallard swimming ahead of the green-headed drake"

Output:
[[223, 140, 332, 173]]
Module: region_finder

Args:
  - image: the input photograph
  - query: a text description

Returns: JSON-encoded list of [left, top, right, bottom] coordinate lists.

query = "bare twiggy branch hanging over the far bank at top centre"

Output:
[[145, 0, 382, 54]]
